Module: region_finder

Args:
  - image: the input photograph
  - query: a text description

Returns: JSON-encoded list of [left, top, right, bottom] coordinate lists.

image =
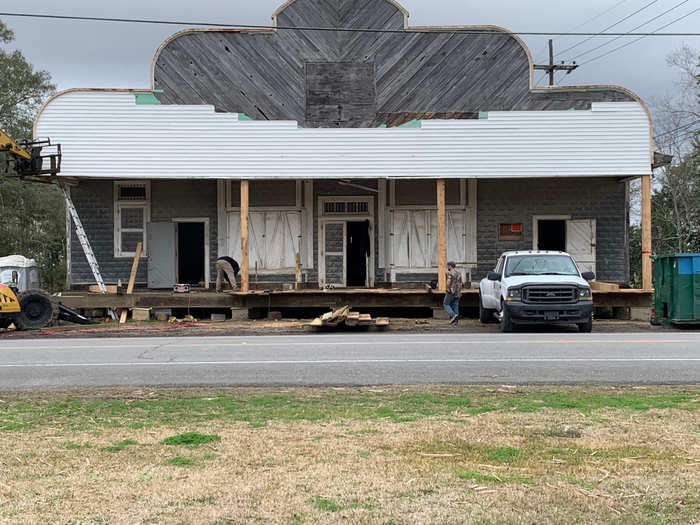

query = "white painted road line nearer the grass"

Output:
[[0, 357, 700, 368]]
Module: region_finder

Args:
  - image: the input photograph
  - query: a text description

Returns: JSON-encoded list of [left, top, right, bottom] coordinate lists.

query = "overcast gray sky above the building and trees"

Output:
[[0, 0, 700, 107]]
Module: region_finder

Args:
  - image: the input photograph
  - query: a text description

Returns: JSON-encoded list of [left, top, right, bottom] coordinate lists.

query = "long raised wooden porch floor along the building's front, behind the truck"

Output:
[[58, 288, 653, 309]]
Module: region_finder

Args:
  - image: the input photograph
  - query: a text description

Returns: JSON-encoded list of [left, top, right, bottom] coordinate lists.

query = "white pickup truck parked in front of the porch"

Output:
[[479, 251, 595, 332]]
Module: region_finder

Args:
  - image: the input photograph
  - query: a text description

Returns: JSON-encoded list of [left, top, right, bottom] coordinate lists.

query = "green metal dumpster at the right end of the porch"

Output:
[[652, 253, 700, 324]]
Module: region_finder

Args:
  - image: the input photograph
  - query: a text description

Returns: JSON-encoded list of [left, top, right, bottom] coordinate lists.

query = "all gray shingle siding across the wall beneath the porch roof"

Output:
[[70, 178, 629, 286]]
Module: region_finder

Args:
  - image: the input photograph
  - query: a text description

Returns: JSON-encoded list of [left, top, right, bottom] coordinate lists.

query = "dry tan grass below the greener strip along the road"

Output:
[[0, 389, 700, 525]]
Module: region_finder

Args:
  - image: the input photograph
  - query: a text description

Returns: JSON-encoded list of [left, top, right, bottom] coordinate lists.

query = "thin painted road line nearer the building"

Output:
[[0, 338, 691, 351]]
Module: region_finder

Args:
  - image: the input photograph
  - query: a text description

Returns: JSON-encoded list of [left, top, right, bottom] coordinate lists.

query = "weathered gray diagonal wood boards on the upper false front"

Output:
[[153, 0, 634, 127]]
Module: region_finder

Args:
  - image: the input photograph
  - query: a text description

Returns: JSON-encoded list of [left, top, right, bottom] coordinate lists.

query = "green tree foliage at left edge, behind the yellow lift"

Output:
[[0, 21, 66, 290]]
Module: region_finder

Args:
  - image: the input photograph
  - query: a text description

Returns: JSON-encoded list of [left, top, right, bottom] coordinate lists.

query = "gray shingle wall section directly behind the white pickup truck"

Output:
[[473, 178, 629, 283]]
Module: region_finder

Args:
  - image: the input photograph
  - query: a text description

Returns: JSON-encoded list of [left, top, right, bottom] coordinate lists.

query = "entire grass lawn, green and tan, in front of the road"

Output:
[[0, 386, 700, 525]]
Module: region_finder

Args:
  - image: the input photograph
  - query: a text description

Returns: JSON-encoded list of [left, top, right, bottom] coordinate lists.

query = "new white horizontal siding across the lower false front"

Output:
[[35, 91, 651, 179]]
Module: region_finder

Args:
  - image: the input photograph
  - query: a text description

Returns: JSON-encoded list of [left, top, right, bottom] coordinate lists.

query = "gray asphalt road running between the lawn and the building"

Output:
[[0, 332, 700, 389]]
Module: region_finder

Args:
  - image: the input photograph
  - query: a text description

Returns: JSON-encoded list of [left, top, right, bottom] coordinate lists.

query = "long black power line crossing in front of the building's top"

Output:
[[0, 10, 700, 36]]
